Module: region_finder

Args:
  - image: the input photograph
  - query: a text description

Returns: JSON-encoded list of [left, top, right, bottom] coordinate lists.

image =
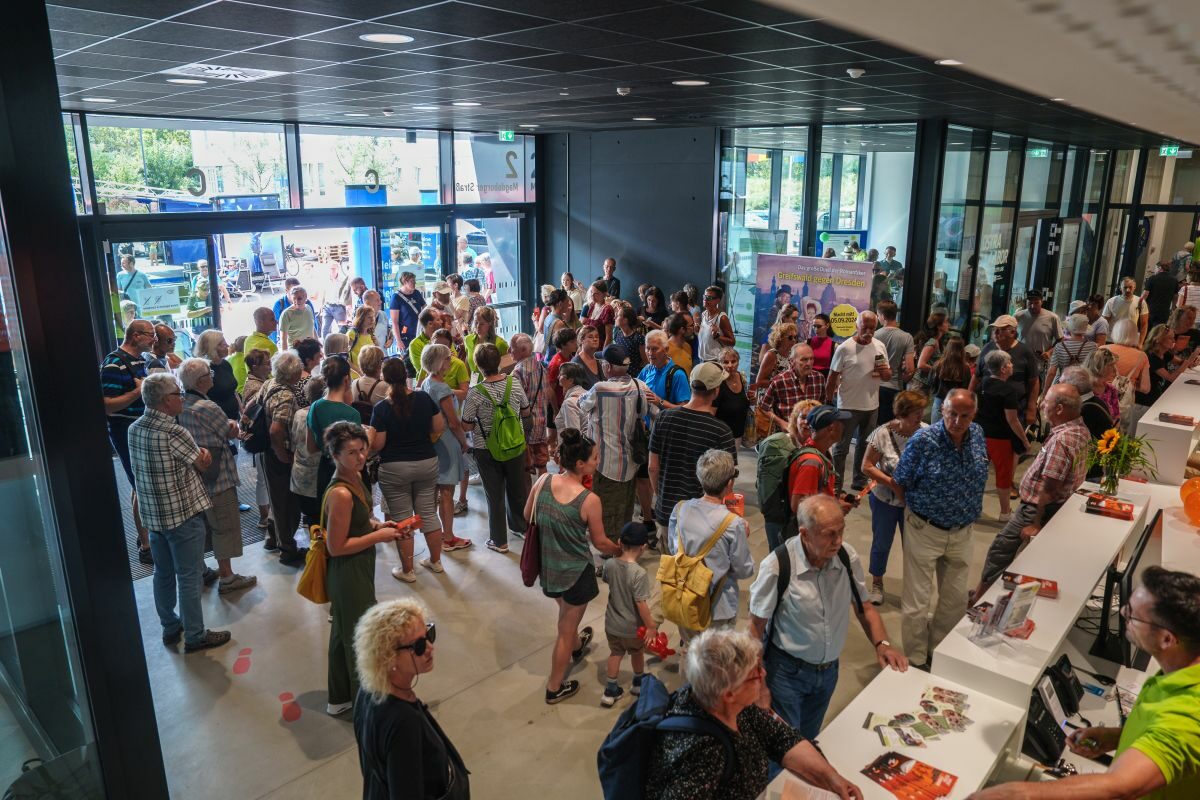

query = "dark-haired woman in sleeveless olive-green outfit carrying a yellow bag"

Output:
[[320, 421, 412, 716]]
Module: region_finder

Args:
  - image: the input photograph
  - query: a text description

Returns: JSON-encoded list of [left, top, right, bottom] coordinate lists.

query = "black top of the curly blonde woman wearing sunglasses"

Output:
[[354, 690, 470, 800]]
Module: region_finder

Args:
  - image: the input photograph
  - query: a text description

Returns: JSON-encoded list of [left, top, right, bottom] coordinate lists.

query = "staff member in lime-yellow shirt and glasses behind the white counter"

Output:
[[970, 566, 1200, 800]]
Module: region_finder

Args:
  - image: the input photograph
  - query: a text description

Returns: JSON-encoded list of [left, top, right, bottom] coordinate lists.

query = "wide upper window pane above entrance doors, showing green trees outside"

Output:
[[88, 115, 288, 213]]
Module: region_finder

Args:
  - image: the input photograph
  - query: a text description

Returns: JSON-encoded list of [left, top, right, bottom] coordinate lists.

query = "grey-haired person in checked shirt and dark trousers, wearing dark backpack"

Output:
[[259, 352, 307, 566]]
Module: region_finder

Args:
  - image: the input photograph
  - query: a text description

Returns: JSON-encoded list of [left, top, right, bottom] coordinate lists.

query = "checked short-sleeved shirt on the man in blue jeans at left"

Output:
[[130, 408, 211, 531]]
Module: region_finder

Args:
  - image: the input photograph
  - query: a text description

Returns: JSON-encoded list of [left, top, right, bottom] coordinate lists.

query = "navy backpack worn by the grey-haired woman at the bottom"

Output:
[[596, 673, 736, 800]]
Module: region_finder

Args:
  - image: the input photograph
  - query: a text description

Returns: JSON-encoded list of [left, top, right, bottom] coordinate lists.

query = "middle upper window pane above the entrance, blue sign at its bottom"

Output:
[[300, 125, 442, 209]]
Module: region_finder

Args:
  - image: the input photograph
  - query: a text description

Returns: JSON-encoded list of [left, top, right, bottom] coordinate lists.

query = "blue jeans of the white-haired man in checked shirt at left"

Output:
[[150, 513, 204, 644]]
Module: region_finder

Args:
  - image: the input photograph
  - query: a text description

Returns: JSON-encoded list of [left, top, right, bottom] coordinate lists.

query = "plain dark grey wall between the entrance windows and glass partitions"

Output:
[[542, 128, 718, 299]]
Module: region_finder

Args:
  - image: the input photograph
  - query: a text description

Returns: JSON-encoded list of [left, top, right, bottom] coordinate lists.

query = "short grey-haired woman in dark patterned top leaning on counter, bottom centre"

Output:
[[646, 628, 863, 800]]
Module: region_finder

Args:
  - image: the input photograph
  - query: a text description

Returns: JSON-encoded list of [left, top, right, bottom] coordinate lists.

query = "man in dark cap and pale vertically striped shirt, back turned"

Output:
[[580, 344, 654, 541]]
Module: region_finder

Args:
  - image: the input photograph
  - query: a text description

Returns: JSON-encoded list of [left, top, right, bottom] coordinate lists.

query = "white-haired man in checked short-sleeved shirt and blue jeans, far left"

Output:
[[128, 372, 230, 652]]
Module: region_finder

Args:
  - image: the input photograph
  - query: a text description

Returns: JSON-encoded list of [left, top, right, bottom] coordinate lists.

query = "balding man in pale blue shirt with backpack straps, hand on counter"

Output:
[[750, 494, 908, 739]]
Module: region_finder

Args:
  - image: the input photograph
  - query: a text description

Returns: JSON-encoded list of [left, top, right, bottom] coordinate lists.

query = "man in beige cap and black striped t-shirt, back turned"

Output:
[[649, 361, 738, 553]]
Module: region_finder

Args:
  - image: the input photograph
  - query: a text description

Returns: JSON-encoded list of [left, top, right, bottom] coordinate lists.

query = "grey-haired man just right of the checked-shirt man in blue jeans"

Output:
[[179, 359, 258, 595]]
